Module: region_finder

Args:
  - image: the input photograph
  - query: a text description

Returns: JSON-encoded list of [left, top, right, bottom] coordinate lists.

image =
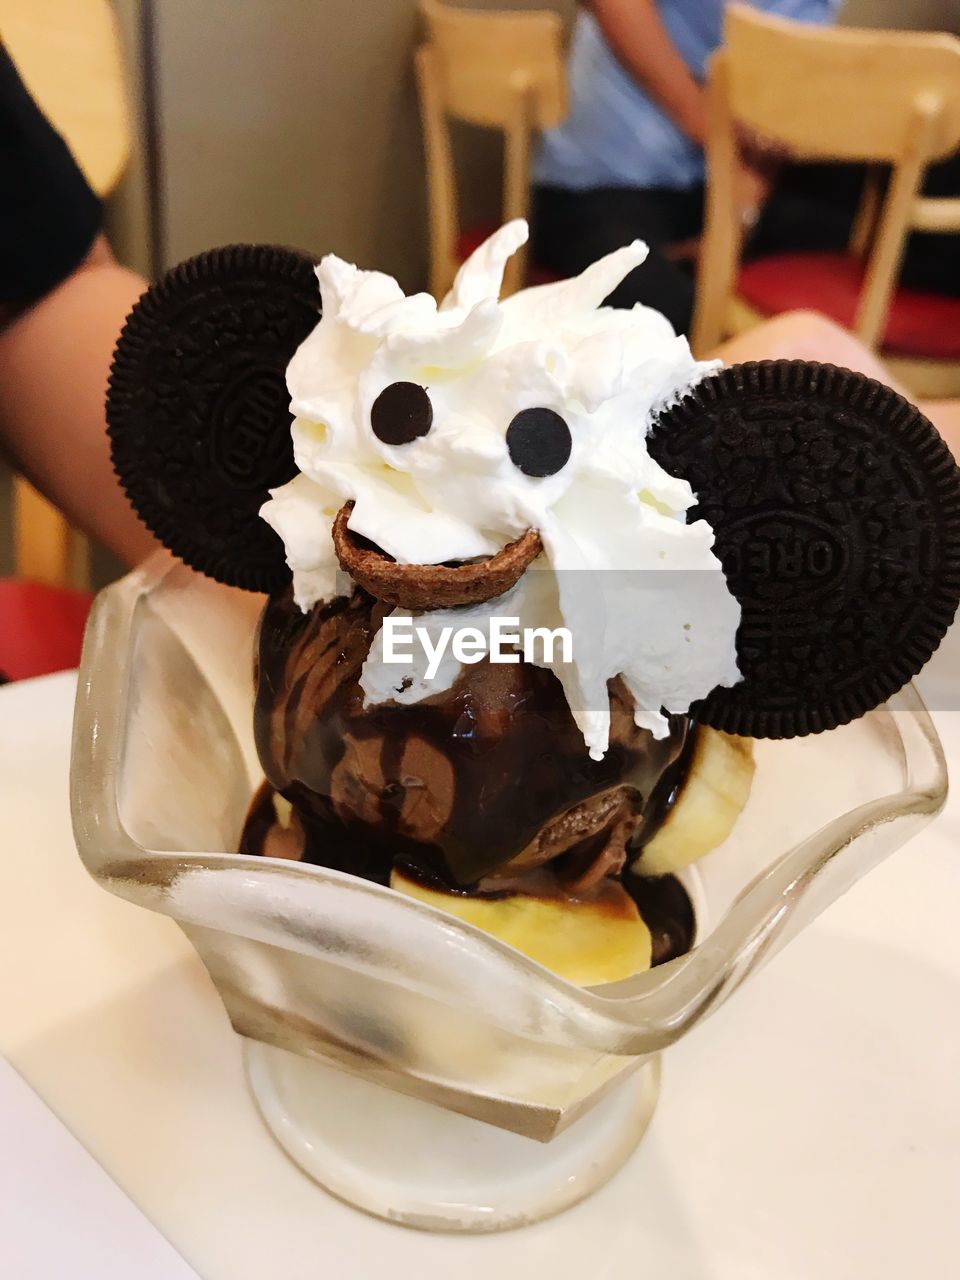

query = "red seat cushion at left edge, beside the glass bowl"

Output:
[[0, 579, 93, 680]]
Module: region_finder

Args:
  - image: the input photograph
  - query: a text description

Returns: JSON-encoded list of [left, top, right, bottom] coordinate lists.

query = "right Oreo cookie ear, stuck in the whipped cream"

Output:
[[648, 360, 960, 737]]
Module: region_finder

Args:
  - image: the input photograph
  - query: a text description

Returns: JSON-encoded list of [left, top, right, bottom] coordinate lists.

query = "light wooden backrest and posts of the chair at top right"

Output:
[[694, 5, 960, 351]]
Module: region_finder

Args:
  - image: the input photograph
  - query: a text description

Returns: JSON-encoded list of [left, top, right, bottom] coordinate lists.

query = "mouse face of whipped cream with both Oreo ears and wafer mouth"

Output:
[[108, 223, 960, 760]]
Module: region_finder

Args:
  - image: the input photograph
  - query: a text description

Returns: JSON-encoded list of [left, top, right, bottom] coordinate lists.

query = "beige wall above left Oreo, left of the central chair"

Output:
[[113, 0, 575, 288]]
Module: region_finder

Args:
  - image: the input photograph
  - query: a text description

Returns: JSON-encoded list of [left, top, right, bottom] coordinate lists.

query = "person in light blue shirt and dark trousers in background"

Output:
[[531, 0, 840, 333]]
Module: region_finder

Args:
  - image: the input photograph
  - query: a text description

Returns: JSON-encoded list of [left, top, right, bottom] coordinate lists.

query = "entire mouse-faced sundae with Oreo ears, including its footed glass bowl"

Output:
[[84, 221, 960, 1230]]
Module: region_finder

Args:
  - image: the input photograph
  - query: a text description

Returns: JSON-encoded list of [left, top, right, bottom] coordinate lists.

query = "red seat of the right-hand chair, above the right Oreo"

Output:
[[737, 253, 960, 360]]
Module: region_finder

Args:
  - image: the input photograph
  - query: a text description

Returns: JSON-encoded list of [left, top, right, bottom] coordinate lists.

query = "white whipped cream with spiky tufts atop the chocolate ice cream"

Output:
[[261, 220, 740, 759]]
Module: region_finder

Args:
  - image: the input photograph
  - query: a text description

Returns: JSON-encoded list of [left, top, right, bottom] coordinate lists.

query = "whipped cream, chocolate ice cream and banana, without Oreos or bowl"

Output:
[[235, 223, 751, 983]]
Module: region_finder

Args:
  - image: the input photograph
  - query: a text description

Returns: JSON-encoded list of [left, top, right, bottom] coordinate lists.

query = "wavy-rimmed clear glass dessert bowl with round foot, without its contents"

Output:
[[72, 557, 947, 1230]]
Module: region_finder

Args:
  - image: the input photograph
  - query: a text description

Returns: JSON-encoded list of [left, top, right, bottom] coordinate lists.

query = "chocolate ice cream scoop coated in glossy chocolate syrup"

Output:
[[255, 591, 690, 893]]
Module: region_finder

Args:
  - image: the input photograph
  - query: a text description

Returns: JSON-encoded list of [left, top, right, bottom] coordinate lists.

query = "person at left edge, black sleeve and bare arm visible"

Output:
[[0, 45, 156, 564]]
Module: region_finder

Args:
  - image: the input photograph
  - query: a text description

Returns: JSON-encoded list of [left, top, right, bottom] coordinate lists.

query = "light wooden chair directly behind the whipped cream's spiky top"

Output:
[[416, 0, 566, 298]]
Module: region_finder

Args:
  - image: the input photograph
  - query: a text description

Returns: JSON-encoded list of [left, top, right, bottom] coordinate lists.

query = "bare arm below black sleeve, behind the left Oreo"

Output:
[[0, 237, 157, 564]]
